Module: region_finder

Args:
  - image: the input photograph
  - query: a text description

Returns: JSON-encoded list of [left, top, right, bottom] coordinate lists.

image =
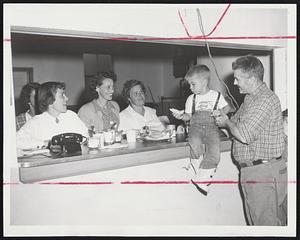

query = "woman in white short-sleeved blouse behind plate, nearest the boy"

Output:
[[119, 79, 164, 131]]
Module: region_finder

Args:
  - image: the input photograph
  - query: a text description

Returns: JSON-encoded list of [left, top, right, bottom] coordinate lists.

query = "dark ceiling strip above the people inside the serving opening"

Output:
[[11, 33, 270, 58]]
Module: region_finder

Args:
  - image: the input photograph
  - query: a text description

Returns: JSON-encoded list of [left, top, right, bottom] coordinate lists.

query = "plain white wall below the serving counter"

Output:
[[11, 152, 245, 229]]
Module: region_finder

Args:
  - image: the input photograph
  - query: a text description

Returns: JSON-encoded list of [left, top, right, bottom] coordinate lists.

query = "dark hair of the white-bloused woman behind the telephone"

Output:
[[38, 82, 66, 113]]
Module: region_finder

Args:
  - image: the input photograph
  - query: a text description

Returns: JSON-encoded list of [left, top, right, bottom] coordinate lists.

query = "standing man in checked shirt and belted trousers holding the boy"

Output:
[[216, 55, 287, 226]]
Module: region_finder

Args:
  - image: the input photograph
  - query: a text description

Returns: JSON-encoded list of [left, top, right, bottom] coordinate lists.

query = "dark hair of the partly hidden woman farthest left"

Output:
[[19, 82, 40, 112]]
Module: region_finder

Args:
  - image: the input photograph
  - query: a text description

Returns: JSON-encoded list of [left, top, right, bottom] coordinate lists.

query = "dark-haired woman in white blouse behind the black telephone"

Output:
[[17, 82, 88, 149]]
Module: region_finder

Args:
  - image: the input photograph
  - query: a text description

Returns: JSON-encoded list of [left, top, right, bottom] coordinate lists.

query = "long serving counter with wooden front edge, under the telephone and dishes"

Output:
[[18, 137, 231, 183]]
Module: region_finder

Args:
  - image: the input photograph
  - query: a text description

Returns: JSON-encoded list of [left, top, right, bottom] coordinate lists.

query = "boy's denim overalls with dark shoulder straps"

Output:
[[189, 92, 220, 169]]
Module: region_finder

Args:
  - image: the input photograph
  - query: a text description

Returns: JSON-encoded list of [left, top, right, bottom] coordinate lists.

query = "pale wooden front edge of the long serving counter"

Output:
[[19, 140, 231, 183]]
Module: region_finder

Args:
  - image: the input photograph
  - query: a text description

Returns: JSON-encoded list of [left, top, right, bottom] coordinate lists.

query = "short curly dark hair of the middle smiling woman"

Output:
[[87, 72, 117, 100]]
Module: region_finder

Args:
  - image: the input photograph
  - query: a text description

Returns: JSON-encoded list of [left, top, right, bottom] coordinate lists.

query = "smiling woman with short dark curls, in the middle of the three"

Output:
[[78, 72, 120, 133]]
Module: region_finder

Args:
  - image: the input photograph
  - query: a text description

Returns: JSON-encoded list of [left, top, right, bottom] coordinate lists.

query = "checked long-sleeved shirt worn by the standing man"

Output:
[[231, 83, 284, 162]]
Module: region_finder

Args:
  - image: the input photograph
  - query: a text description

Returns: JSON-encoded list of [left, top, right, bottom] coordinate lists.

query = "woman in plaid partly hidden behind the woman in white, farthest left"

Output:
[[16, 82, 40, 131]]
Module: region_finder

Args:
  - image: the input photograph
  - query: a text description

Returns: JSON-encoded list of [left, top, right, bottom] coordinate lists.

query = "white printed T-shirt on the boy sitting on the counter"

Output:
[[185, 89, 228, 114]]
